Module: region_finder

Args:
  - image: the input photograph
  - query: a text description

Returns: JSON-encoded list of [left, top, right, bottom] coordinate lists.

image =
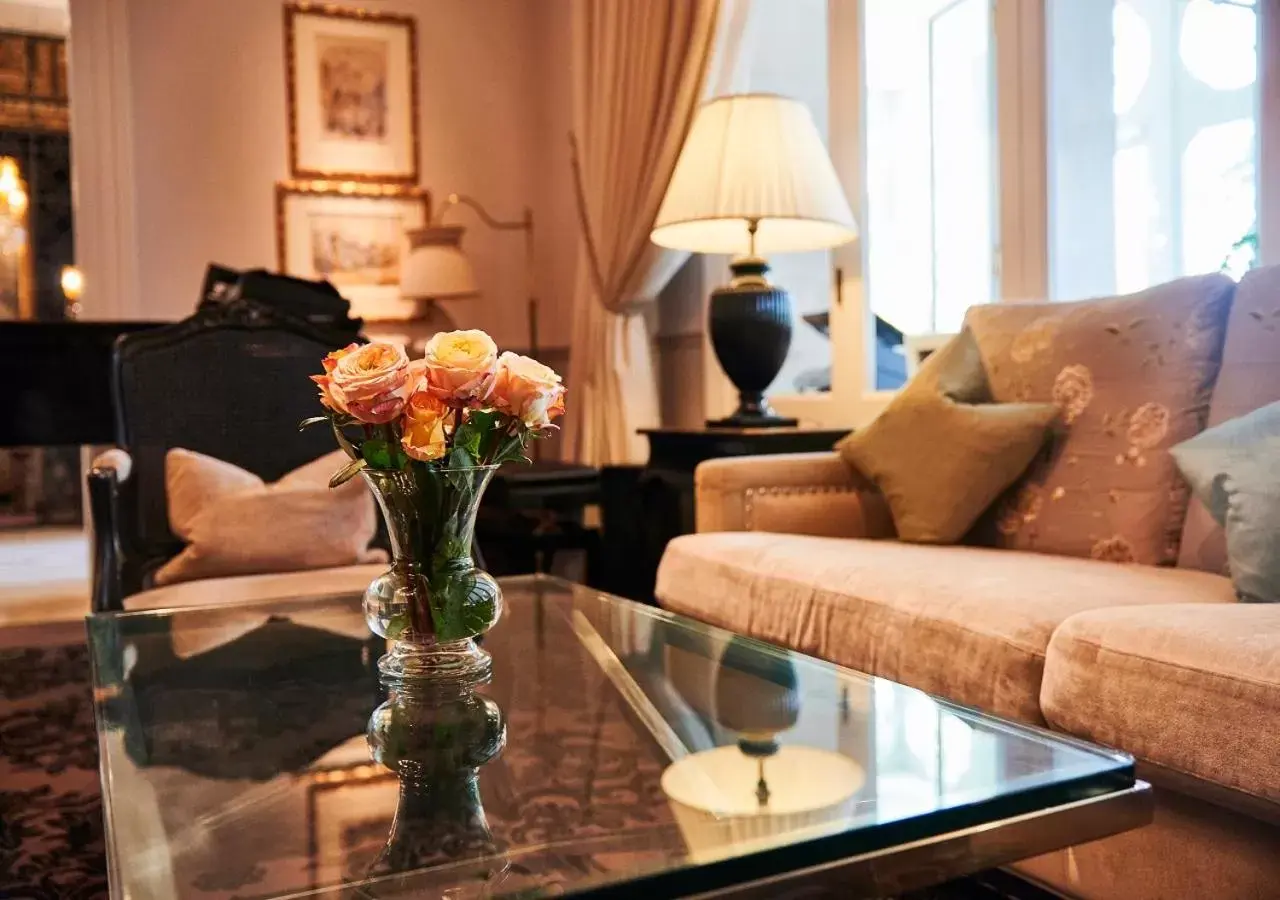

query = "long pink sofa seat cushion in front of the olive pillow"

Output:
[[657, 533, 1235, 725]]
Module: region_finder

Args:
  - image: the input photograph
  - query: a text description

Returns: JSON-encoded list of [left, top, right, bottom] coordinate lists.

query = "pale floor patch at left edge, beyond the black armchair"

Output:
[[0, 527, 90, 627]]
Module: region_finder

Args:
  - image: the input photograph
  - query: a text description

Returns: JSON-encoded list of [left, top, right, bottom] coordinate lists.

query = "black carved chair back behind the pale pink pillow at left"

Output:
[[113, 301, 352, 594]]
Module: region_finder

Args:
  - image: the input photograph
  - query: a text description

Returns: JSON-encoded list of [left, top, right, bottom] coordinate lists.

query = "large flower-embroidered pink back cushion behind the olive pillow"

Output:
[[966, 274, 1235, 565]]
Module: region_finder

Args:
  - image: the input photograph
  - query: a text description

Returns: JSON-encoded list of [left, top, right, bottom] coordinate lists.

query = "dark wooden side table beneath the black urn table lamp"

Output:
[[600, 428, 849, 603]]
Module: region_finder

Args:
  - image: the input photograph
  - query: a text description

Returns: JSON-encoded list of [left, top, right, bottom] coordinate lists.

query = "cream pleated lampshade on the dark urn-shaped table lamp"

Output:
[[650, 93, 858, 256]]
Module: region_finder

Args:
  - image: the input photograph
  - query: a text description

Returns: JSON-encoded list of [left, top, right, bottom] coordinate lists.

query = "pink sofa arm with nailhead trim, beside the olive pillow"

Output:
[[695, 453, 893, 538]]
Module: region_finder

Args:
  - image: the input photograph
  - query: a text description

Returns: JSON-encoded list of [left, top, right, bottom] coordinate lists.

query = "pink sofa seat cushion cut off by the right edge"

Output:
[[1041, 603, 1280, 803]]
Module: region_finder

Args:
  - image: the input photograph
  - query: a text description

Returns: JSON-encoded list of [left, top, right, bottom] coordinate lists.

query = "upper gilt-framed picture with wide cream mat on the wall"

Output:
[[284, 4, 419, 184]]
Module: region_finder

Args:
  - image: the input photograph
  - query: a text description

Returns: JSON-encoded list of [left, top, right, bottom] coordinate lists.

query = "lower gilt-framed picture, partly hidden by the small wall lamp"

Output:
[[275, 182, 431, 320]]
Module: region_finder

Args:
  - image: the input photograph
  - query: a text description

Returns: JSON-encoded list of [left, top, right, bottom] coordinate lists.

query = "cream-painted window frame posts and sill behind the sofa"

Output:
[[769, 0, 1280, 428]]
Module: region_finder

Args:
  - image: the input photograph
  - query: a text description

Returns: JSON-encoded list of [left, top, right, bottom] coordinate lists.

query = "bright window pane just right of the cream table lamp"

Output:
[[863, 0, 996, 388]]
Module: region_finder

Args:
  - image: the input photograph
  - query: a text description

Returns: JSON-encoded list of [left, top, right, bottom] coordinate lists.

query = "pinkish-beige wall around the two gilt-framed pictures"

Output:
[[72, 0, 573, 347]]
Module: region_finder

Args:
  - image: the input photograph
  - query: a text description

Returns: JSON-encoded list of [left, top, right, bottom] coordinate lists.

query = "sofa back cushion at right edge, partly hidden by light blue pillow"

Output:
[[1178, 266, 1280, 574]]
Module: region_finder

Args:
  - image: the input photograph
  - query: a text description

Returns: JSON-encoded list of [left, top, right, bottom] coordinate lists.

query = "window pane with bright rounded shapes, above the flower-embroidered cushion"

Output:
[[1046, 0, 1258, 300]]
